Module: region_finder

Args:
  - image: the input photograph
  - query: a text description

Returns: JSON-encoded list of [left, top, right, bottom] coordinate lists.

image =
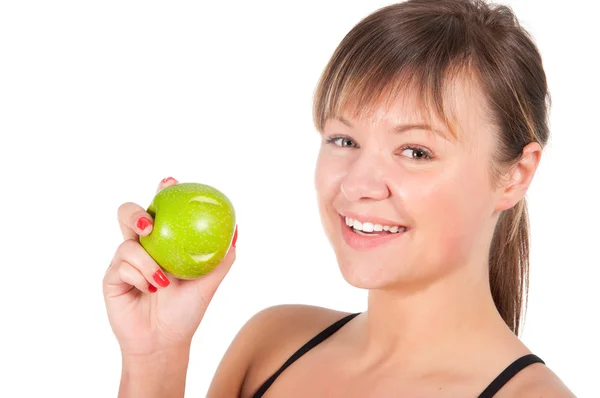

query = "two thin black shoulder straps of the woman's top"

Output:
[[254, 312, 545, 398]]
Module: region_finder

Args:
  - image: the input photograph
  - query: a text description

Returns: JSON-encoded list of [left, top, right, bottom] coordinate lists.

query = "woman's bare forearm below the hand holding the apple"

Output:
[[119, 346, 190, 398]]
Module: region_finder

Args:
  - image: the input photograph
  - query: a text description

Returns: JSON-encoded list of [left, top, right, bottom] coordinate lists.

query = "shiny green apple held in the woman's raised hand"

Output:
[[140, 182, 236, 279]]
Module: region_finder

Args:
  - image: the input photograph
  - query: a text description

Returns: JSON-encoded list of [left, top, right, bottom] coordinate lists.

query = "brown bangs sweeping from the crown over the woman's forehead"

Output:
[[313, 4, 477, 139]]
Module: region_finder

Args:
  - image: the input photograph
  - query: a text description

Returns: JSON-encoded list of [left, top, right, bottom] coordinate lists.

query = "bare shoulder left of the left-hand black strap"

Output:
[[207, 304, 350, 397]]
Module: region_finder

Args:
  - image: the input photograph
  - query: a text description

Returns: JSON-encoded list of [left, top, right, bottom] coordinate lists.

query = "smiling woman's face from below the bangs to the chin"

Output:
[[315, 78, 498, 289]]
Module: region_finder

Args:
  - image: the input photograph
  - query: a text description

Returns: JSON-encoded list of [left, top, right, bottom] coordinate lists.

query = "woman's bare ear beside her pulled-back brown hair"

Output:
[[496, 142, 542, 211]]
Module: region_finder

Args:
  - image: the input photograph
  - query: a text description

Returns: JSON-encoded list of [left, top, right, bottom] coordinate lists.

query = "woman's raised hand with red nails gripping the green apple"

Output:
[[103, 178, 237, 398]]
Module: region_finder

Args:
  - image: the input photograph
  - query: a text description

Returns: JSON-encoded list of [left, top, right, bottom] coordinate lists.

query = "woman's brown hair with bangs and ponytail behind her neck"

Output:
[[313, 0, 551, 335]]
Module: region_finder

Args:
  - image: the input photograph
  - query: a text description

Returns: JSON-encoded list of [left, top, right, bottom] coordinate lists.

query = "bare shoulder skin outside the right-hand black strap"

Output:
[[503, 364, 576, 398]]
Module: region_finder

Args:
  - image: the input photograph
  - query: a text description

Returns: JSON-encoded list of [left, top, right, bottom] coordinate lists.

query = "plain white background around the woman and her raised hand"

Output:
[[0, 0, 600, 397]]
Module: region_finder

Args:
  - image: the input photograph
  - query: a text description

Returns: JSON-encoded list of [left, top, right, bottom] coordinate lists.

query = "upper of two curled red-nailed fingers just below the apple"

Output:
[[115, 236, 171, 288]]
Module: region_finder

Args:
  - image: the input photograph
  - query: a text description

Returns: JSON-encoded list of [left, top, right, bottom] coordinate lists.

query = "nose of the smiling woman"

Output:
[[340, 154, 391, 202]]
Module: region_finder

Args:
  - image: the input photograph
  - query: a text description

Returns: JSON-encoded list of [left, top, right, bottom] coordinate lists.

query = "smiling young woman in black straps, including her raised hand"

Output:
[[104, 0, 573, 398]]
